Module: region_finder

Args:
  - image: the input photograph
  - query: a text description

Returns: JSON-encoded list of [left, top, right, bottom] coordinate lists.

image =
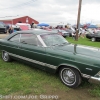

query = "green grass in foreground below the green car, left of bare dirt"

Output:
[[0, 54, 69, 95]]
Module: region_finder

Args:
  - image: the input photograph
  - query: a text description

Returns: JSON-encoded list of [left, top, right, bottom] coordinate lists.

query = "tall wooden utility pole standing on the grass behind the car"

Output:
[[75, 0, 82, 41]]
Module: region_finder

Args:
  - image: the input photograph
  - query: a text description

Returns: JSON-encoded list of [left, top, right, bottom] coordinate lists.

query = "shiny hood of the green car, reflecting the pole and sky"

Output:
[[55, 44, 100, 58]]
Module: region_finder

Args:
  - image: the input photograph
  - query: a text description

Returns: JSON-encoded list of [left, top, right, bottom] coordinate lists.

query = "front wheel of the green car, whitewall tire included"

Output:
[[59, 67, 81, 88]]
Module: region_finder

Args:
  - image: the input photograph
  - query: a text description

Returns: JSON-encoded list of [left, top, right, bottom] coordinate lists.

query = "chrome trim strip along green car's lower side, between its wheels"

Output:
[[8, 53, 57, 70]]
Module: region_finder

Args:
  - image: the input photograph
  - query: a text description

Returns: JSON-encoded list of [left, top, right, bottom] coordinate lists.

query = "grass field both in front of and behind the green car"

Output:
[[0, 38, 100, 100]]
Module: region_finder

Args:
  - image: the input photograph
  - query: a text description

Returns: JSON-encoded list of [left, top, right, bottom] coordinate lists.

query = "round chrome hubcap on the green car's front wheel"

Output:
[[62, 69, 75, 84]]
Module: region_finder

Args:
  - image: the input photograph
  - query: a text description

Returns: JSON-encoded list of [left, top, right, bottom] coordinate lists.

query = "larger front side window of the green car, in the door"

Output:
[[20, 33, 42, 46]]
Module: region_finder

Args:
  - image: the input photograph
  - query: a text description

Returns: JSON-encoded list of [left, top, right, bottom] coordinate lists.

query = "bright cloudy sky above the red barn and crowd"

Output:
[[0, 0, 100, 24]]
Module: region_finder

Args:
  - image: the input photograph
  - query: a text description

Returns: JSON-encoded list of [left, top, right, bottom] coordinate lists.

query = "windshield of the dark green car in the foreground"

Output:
[[41, 33, 68, 46]]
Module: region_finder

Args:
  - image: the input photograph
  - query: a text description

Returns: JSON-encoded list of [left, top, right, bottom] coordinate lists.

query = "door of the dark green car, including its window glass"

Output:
[[20, 33, 45, 70]]
